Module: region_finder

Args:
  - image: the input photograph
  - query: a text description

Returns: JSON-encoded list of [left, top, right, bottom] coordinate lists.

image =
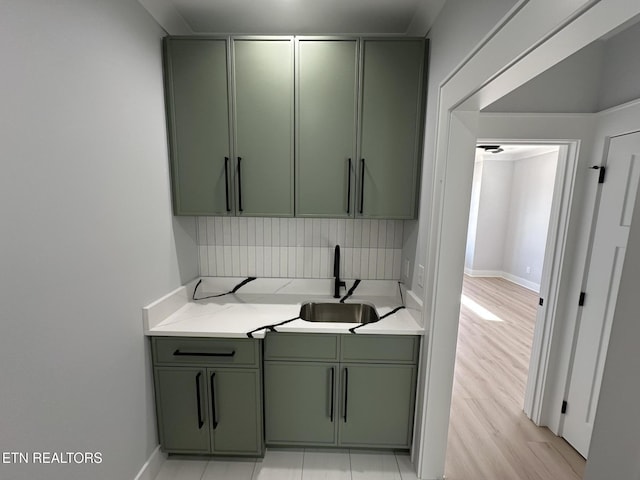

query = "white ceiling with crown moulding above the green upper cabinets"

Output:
[[139, 0, 446, 36]]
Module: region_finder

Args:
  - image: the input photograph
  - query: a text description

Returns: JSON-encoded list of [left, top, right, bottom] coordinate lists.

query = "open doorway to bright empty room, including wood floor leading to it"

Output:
[[445, 142, 585, 480]]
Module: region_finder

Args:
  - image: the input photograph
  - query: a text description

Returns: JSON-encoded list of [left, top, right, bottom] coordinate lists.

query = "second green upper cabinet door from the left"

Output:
[[233, 39, 293, 216]]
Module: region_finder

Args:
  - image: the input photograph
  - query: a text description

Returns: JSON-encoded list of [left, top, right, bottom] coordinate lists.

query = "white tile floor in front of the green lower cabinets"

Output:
[[156, 448, 418, 480]]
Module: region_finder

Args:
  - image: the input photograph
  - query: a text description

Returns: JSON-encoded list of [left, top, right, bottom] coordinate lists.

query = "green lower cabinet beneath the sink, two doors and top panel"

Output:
[[264, 333, 420, 449]]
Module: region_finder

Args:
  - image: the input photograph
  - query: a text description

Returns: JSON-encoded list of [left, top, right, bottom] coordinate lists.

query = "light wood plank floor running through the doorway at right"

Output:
[[445, 276, 585, 480]]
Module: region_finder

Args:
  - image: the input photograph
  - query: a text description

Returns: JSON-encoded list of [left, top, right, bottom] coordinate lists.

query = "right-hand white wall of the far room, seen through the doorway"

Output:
[[502, 152, 558, 284]]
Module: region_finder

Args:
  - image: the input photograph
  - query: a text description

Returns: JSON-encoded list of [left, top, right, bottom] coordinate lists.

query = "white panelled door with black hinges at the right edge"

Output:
[[562, 132, 640, 458]]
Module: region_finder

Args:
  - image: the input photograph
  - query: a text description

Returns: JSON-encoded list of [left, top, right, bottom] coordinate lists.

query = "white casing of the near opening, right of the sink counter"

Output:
[[414, 0, 640, 479]]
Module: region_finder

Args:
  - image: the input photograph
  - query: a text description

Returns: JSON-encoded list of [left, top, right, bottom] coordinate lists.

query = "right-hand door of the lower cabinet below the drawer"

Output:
[[208, 368, 263, 456]]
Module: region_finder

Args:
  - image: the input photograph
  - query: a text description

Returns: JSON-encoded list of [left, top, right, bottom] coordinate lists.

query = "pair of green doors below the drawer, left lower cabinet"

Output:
[[154, 367, 264, 456]]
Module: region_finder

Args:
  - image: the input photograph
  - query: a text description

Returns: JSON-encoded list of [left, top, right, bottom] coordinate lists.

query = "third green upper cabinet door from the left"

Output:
[[296, 39, 358, 218]]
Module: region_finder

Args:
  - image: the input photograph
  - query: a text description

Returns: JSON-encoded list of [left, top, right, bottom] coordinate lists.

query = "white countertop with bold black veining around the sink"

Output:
[[143, 277, 424, 338]]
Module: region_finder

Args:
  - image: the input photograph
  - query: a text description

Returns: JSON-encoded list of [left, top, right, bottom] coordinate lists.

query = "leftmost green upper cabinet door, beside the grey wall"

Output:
[[165, 38, 233, 215]]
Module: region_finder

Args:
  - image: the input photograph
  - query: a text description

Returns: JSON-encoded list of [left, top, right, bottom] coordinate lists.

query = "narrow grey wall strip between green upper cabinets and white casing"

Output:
[[402, 0, 516, 298]]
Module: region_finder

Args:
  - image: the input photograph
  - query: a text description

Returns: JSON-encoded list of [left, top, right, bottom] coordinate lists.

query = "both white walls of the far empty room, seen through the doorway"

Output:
[[465, 147, 558, 291]]
